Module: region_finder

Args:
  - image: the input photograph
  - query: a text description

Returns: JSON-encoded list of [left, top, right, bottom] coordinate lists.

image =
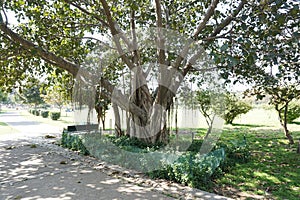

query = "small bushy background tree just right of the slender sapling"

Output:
[[223, 93, 252, 124]]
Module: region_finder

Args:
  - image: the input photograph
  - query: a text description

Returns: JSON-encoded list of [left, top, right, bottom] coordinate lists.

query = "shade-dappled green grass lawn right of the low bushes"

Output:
[[212, 124, 300, 199]]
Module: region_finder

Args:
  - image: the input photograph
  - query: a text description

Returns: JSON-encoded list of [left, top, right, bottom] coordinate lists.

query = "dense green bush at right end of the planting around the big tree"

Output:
[[148, 138, 251, 189]]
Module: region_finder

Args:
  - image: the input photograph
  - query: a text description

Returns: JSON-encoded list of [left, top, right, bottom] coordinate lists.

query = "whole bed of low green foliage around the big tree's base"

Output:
[[61, 132, 250, 189]]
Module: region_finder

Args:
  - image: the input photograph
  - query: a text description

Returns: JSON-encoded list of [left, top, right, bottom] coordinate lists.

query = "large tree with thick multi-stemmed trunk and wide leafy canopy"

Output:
[[0, 0, 300, 142]]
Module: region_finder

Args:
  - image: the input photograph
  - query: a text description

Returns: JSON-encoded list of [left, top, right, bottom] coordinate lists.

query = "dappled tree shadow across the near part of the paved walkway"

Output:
[[0, 142, 172, 200]]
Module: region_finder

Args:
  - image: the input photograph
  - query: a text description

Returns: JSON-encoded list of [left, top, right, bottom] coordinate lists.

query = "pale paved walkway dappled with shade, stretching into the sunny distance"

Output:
[[0, 112, 232, 200]]
